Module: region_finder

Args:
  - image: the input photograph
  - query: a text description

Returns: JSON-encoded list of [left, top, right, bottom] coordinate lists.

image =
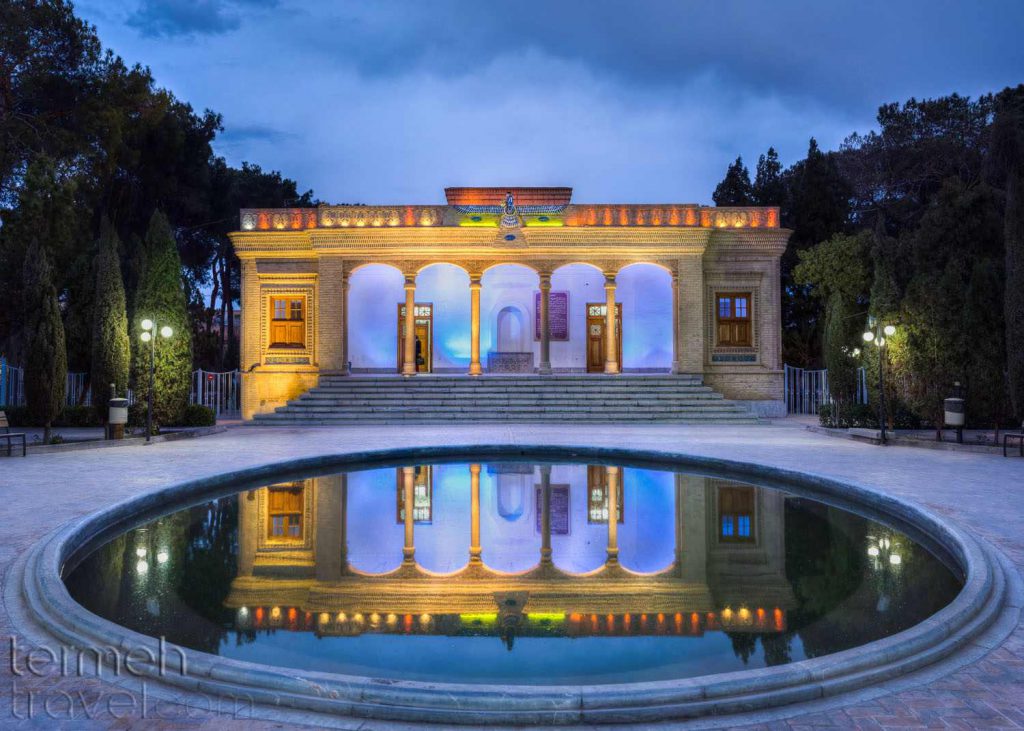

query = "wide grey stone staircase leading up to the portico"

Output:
[[253, 374, 760, 425]]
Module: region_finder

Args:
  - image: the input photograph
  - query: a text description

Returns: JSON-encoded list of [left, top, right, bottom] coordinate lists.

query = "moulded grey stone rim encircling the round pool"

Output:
[[19, 444, 1011, 724]]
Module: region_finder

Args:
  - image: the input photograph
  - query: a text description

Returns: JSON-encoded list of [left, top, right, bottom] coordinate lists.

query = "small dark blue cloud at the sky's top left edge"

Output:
[[126, 0, 278, 38]]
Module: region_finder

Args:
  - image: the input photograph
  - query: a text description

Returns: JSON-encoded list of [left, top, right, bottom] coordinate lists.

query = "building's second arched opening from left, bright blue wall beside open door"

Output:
[[416, 262, 471, 373]]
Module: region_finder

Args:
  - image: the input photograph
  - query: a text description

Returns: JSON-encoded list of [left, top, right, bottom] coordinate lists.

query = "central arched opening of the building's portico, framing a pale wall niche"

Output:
[[480, 264, 540, 373]]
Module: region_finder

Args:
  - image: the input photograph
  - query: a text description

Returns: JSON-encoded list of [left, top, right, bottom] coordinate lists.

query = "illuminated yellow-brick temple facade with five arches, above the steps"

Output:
[[230, 187, 790, 419]]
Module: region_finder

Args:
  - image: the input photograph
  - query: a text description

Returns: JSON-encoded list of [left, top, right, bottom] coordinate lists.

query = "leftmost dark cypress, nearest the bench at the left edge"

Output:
[[24, 238, 68, 443]]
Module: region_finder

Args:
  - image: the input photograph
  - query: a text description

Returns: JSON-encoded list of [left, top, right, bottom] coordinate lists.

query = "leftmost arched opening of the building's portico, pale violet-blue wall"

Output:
[[348, 262, 406, 373]]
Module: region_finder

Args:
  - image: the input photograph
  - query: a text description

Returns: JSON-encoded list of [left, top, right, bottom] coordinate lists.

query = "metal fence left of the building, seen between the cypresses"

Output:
[[0, 358, 242, 419]]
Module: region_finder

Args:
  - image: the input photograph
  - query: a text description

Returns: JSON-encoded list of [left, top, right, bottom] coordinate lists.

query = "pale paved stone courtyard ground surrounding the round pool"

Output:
[[0, 421, 1024, 729]]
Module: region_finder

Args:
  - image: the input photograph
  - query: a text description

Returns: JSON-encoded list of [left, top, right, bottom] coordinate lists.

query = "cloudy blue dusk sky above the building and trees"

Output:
[[76, 0, 1024, 204]]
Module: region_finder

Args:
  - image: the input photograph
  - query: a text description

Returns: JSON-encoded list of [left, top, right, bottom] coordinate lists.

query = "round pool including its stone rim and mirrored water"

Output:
[[26, 446, 1002, 723]]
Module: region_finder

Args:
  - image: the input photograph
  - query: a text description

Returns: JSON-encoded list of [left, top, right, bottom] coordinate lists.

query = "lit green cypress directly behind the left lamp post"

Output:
[[131, 211, 193, 425]]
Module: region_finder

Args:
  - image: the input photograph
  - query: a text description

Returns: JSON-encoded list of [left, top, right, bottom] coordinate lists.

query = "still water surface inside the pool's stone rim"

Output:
[[66, 462, 962, 685]]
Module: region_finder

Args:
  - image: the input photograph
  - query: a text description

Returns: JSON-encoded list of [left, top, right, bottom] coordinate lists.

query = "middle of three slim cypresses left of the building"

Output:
[[92, 219, 131, 409]]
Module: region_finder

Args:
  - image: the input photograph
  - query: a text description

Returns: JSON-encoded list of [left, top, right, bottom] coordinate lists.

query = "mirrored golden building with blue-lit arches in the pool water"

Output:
[[226, 464, 794, 636]]
